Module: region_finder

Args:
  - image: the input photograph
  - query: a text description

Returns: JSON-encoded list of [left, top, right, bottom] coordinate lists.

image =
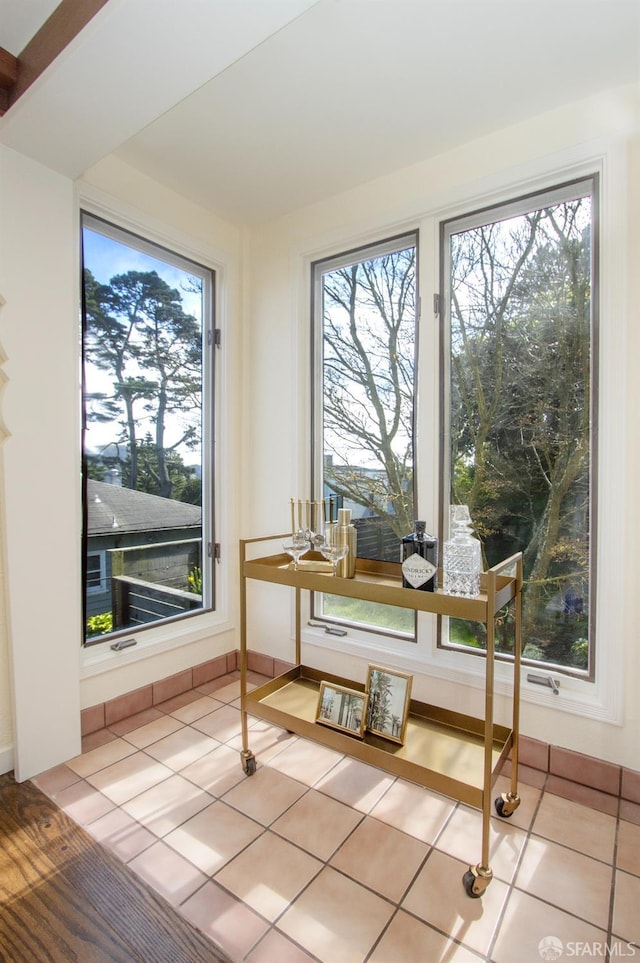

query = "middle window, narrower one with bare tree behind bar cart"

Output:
[[313, 234, 417, 639]]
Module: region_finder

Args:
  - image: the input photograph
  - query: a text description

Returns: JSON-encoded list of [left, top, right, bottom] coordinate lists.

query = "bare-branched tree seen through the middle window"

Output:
[[323, 247, 416, 537]]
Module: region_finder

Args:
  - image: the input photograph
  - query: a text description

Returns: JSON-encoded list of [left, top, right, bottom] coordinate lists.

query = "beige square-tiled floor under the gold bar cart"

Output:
[[34, 673, 640, 963]]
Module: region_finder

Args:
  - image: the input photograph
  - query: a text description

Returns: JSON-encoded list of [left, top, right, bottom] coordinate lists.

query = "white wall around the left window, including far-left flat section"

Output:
[[0, 148, 241, 780]]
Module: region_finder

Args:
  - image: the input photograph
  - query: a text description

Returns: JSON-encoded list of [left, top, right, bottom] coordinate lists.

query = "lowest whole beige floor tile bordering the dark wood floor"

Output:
[[180, 882, 269, 963]]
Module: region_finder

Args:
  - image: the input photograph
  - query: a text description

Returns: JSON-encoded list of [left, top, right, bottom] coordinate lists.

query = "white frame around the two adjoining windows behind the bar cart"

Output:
[[297, 142, 627, 725]]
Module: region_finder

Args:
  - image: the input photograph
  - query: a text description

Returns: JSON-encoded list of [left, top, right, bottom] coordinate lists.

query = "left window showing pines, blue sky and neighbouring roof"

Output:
[[82, 214, 215, 642]]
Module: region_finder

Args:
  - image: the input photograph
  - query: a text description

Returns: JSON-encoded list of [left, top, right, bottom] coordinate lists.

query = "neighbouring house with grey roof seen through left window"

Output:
[[86, 480, 202, 618]]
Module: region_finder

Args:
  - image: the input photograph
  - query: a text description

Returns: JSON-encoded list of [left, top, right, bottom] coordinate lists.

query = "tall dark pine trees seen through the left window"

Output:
[[84, 270, 202, 498]]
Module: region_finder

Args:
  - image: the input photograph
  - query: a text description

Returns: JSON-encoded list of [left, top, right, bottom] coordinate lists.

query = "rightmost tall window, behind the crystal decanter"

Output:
[[442, 178, 597, 677]]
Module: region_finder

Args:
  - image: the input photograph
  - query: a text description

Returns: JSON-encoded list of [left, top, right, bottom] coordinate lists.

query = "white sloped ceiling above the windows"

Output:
[[0, 0, 640, 224]]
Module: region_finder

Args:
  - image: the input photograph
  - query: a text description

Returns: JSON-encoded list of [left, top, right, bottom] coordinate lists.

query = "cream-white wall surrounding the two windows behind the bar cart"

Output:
[[243, 88, 640, 769]]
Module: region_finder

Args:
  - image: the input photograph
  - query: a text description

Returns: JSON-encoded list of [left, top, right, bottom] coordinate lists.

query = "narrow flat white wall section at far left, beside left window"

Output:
[[0, 149, 81, 778]]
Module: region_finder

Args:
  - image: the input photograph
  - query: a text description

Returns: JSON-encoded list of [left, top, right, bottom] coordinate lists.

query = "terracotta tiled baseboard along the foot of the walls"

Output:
[[82, 650, 640, 824]]
